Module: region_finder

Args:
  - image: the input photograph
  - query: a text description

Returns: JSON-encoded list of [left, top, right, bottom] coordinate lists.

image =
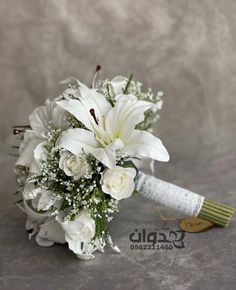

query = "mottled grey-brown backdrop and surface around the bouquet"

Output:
[[0, 0, 236, 290]]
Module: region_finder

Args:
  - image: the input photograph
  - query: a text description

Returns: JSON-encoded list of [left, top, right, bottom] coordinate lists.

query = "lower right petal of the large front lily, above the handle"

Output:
[[123, 130, 170, 162]]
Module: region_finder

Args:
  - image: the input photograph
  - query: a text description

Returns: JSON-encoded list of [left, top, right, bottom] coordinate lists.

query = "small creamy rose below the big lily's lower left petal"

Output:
[[59, 152, 91, 180]]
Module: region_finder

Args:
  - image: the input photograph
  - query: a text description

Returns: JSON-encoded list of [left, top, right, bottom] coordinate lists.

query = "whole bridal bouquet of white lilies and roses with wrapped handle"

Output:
[[13, 67, 232, 259]]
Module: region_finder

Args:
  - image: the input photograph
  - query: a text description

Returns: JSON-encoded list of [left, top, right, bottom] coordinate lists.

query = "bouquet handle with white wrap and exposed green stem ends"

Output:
[[136, 171, 235, 227]]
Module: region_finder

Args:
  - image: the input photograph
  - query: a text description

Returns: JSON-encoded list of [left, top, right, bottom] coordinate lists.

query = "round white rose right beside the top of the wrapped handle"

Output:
[[101, 166, 136, 200]]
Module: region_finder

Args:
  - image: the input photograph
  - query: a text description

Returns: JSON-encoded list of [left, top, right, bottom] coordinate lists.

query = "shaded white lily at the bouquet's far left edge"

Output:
[[16, 101, 68, 173]]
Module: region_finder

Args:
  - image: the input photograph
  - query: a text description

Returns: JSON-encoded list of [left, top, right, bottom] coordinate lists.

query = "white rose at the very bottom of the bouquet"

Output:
[[59, 210, 95, 259]]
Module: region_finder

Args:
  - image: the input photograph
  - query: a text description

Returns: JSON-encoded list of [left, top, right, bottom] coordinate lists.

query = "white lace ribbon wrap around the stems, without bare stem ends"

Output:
[[136, 172, 204, 216]]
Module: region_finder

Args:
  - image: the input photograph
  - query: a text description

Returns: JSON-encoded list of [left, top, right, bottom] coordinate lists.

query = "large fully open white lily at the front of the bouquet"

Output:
[[57, 87, 169, 169]]
